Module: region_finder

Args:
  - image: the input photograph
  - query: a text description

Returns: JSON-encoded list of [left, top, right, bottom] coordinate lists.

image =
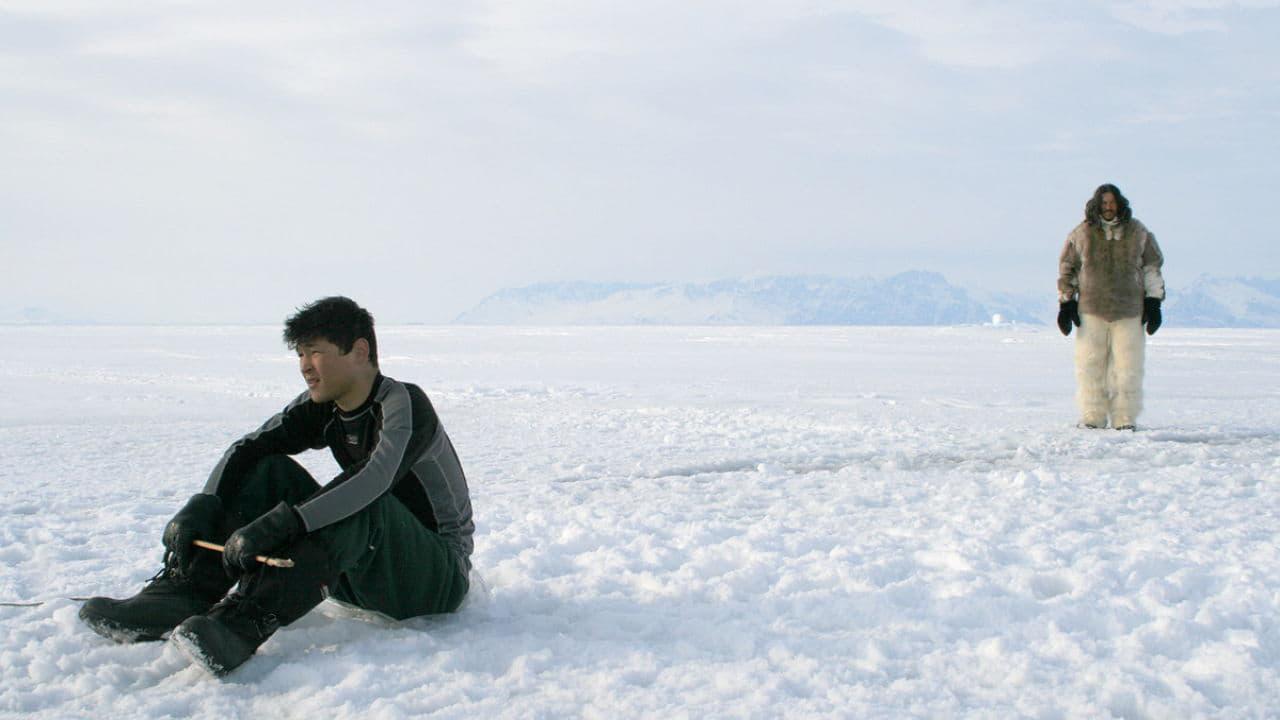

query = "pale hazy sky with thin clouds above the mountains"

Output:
[[0, 0, 1280, 323]]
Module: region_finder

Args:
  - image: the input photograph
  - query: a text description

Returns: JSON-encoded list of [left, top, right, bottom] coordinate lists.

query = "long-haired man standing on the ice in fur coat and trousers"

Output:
[[1057, 184, 1165, 430]]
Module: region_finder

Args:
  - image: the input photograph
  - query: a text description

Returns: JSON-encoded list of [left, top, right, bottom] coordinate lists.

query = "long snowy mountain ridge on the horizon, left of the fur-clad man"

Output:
[[456, 272, 1052, 325]]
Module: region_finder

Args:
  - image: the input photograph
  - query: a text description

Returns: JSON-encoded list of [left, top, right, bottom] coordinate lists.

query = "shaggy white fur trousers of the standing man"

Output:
[[1075, 314, 1147, 428]]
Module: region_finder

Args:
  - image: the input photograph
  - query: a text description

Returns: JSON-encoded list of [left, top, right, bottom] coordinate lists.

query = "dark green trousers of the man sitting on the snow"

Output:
[[221, 455, 470, 623]]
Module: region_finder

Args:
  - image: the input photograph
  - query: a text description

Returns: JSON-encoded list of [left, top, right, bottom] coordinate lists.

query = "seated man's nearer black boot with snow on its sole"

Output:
[[172, 538, 335, 678]]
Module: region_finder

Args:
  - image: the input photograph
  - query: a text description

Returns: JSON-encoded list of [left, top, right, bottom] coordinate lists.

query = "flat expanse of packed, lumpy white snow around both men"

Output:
[[0, 325, 1280, 720]]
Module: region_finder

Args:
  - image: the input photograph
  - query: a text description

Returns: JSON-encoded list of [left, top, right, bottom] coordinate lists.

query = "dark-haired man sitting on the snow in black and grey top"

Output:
[[79, 297, 475, 675]]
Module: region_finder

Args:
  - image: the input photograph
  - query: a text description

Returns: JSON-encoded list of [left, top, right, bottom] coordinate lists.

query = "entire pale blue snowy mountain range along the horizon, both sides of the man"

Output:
[[454, 270, 1280, 328]]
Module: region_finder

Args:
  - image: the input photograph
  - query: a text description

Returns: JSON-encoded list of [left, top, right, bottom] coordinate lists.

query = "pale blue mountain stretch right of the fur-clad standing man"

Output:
[[1165, 275, 1280, 328]]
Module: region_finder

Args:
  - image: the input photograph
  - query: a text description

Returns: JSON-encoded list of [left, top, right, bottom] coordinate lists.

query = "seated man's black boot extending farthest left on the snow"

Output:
[[79, 552, 233, 643]]
